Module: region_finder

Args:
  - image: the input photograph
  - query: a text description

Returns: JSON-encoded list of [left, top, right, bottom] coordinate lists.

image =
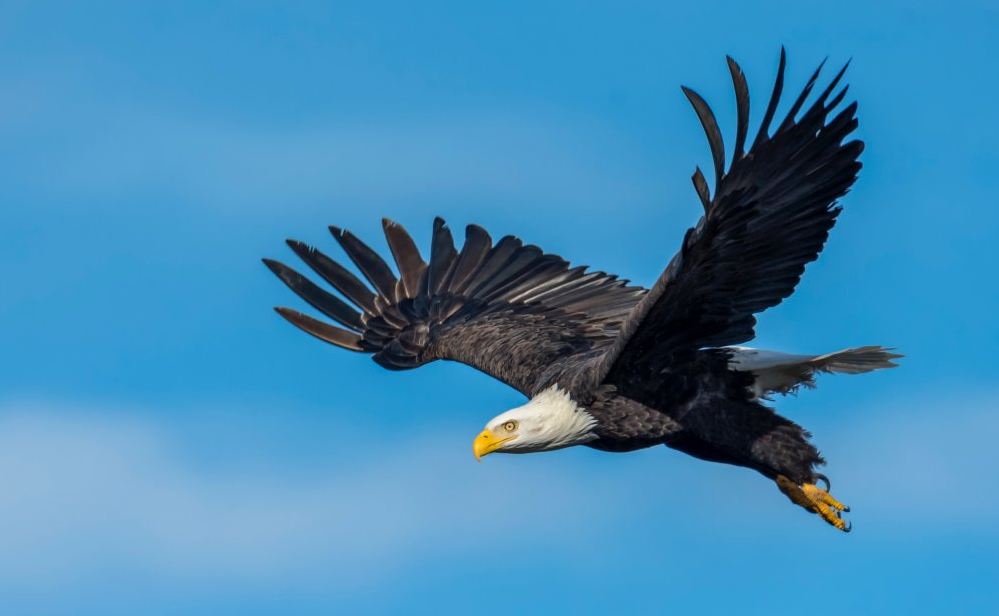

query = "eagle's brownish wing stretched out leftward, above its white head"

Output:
[[264, 218, 645, 395]]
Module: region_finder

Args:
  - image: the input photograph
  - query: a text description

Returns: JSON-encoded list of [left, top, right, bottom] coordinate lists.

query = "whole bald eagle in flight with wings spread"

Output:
[[264, 49, 901, 531]]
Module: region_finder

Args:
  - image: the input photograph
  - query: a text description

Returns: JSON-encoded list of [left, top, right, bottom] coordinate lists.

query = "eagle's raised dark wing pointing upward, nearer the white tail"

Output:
[[590, 49, 863, 384]]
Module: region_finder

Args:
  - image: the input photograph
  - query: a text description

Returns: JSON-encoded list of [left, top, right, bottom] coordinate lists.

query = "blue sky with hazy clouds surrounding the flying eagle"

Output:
[[0, 0, 999, 616]]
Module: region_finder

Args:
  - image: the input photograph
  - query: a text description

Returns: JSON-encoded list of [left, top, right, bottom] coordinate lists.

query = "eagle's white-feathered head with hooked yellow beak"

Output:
[[472, 385, 597, 460]]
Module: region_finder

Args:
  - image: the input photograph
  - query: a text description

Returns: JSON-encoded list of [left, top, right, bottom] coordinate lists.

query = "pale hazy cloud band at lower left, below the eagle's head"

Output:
[[0, 408, 608, 589]]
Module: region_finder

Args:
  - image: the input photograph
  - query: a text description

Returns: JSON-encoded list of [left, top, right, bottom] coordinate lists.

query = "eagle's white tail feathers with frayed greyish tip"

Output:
[[728, 346, 902, 397]]
